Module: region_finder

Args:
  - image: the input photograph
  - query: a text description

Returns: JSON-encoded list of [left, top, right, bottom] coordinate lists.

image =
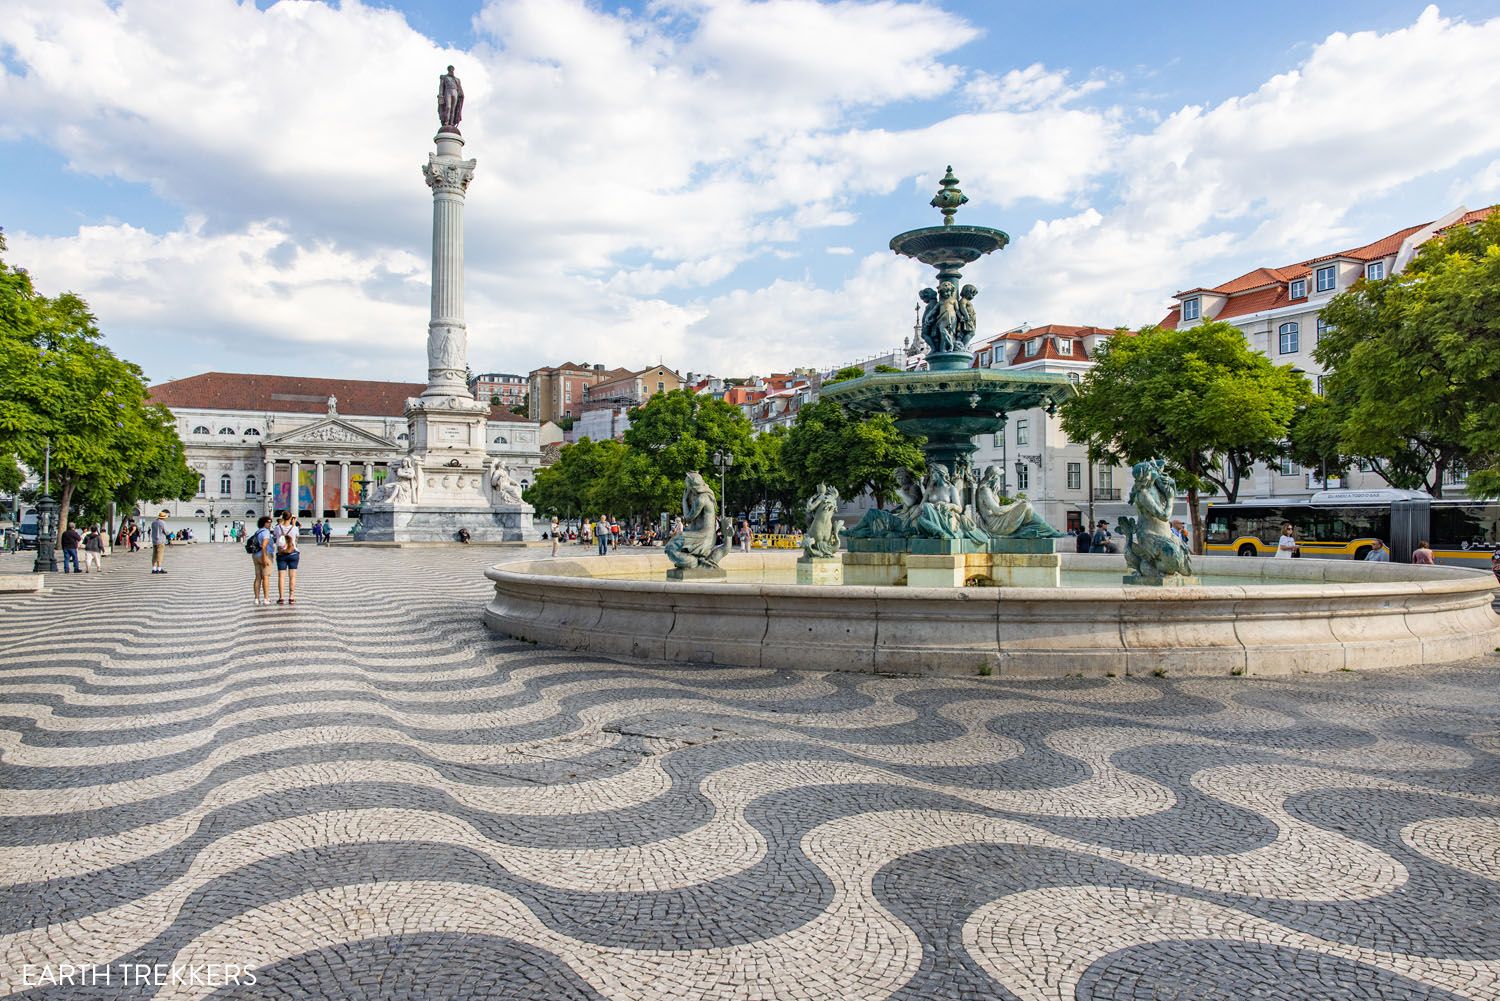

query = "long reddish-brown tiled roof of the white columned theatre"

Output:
[[152, 372, 527, 422]]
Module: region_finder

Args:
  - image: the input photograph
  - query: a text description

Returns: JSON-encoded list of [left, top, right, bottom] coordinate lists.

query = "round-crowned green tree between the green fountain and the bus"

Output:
[[1062, 323, 1313, 552]]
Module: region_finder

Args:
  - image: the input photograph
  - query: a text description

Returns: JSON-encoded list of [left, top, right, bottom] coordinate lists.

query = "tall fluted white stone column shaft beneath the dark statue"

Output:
[[422, 131, 477, 399]]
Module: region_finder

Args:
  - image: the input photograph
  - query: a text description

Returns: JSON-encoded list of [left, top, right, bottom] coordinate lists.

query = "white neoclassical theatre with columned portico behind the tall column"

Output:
[[152, 372, 542, 521]]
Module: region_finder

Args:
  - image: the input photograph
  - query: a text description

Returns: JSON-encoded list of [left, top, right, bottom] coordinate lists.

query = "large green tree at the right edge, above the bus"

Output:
[[1314, 213, 1500, 497]]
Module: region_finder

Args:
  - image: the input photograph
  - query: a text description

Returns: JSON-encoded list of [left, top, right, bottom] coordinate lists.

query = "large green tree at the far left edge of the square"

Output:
[[0, 239, 198, 527]]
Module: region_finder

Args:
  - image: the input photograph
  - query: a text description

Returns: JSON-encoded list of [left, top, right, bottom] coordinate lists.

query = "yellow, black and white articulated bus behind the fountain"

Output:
[[1203, 489, 1500, 570]]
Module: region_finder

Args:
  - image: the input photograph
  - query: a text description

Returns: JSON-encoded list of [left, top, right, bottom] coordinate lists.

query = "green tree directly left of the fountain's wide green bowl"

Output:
[[780, 399, 926, 504]]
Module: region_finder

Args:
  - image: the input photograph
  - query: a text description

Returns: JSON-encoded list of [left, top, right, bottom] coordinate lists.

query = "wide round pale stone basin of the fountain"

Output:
[[485, 552, 1500, 678]]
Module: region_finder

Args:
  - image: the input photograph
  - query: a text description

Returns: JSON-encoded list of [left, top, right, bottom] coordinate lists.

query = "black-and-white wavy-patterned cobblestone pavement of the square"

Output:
[[0, 546, 1500, 1001]]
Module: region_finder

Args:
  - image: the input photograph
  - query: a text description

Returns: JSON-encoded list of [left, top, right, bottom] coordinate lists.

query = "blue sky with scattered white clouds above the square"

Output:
[[0, 0, 1500, 381]]
